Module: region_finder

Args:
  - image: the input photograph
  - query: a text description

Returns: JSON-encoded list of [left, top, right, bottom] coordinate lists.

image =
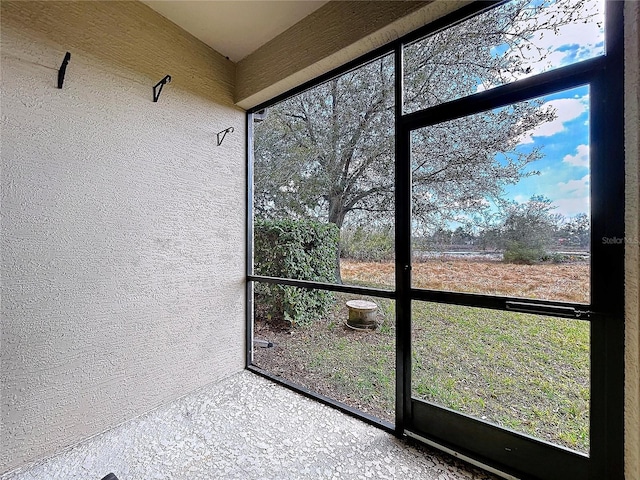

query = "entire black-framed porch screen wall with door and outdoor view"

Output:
[[248, 1, 623, 478]]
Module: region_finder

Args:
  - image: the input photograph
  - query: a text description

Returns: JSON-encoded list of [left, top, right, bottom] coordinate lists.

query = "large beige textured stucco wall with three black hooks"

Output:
[[0, 0, 245, 473]]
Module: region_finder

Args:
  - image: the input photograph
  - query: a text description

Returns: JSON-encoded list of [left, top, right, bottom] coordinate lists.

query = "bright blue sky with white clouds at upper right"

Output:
[[495, 0, 604, 217]]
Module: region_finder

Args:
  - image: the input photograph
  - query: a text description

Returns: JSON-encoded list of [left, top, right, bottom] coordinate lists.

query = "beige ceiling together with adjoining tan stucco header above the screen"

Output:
[[142, 0, 471, 109]]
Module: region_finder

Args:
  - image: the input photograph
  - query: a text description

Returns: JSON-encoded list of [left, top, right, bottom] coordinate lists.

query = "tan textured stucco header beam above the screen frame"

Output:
[[235, 0, 470, 109]]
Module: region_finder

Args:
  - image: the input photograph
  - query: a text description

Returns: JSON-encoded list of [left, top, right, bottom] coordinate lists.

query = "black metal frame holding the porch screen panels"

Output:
[[246, 0, 625, 479]]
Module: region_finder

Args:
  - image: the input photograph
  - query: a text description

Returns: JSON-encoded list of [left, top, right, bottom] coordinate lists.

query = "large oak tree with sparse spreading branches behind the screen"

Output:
[[254, 0, 592, 274]]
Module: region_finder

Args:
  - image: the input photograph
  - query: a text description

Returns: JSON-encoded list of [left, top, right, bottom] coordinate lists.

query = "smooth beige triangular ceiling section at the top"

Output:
[[142, 0, 327, 62]]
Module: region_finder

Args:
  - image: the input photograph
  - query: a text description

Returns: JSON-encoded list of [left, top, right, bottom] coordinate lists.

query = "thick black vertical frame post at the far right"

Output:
[[589, 1, 625, 479]]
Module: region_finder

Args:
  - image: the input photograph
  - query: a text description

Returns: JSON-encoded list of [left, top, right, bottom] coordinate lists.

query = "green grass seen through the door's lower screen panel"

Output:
[[412, 302, 589, 451]]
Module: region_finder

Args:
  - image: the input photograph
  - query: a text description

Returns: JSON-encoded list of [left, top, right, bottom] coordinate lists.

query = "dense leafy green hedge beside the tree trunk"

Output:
[[254, 220, 340, 325]]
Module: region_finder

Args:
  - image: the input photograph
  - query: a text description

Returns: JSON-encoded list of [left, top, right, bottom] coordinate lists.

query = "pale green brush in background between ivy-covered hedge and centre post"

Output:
[[340, 227, 395, 262]]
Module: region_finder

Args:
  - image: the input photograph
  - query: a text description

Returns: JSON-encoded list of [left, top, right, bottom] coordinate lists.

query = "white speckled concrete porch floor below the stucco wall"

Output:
[[0, 371, 496, 480]]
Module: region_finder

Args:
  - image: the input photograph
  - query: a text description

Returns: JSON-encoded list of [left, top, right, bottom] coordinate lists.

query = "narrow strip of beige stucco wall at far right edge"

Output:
[[624, 2, 640, 480]]
